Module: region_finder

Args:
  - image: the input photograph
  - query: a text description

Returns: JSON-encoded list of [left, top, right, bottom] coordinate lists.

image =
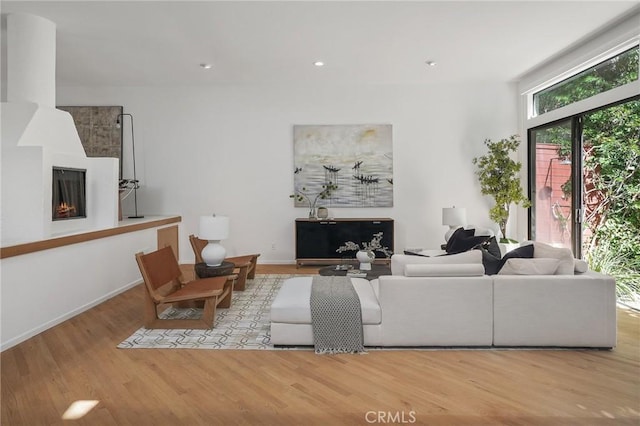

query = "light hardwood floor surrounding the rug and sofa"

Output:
[[1, 265, 640, 426]]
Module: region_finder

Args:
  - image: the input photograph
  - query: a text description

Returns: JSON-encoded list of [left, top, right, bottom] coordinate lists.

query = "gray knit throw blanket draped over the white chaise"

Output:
[[310, 276, 364, 354]]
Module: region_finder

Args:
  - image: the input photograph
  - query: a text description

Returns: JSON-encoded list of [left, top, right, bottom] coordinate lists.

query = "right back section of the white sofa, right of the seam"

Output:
[[493, 271, 616, 348]]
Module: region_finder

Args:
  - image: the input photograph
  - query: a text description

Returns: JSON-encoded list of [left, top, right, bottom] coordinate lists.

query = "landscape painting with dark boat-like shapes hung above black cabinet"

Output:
[[293, 124, 393, 207]]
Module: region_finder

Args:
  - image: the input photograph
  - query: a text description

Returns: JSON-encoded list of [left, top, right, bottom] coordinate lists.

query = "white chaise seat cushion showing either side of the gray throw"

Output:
[[271, 277, 382, 324]]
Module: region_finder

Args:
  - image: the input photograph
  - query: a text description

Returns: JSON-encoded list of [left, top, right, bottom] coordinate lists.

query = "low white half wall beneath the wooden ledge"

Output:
[[0, 218, 173, 350]]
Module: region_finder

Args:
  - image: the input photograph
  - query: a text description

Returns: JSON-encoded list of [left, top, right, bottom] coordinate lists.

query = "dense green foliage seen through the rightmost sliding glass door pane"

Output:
[[583, 100, 640, 296]]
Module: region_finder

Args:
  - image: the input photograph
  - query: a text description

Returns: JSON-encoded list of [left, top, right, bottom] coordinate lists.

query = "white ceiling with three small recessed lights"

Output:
[[1, 0, 638, 86]]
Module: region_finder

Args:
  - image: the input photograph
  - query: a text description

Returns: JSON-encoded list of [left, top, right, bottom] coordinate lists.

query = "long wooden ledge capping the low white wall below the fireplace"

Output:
[[0, 216, 182, 259]]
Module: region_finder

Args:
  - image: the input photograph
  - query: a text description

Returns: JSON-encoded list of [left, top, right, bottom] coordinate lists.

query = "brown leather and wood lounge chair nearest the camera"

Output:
[[136, 246, 237, 329]]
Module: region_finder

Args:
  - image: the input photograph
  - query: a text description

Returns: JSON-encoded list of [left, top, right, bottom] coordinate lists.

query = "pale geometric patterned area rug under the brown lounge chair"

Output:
[[118, 274, 313, 350]]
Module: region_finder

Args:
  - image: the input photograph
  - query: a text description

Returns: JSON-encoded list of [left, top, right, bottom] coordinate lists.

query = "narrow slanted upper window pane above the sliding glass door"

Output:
[[533, 46, 638, 115]]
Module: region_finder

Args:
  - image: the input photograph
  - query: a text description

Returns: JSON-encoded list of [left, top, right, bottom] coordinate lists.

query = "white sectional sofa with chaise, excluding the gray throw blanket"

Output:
[[271, 250, 616, 348]]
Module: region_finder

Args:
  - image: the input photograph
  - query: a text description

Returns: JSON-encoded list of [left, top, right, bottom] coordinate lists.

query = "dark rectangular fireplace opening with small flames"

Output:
[[51, 167, 87, 220]]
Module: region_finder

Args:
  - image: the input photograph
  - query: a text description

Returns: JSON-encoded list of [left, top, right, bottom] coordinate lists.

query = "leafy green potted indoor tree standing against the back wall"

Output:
[[473, 135, 531, 243]]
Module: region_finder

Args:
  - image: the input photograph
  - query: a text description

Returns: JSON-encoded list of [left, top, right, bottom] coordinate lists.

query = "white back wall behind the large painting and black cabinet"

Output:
[[57, 82, 526, 263]]
